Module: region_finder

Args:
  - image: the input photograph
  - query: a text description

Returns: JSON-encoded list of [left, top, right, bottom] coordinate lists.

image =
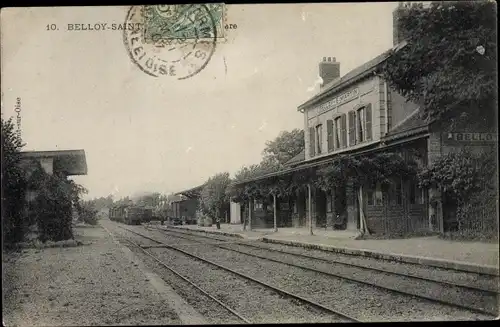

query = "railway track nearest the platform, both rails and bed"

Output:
[[152, 228, 498, 317]]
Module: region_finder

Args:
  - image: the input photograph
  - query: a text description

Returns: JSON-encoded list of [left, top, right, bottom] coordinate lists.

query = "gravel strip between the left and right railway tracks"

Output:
[[143, 228, 488, 321]]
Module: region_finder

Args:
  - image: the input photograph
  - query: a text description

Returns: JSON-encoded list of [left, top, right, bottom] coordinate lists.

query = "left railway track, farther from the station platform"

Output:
[[117, 226, 363, 323]]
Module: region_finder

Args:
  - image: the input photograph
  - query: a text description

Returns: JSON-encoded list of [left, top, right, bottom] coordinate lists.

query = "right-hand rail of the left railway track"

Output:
[[118, 226, 366, 322]]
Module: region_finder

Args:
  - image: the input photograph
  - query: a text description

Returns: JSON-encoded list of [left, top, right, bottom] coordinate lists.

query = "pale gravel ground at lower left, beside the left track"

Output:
[[3, 227, 180, 326]]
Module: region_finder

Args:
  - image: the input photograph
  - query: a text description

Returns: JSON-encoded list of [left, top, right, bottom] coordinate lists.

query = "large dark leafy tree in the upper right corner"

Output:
[[383, 1, 497, 129]]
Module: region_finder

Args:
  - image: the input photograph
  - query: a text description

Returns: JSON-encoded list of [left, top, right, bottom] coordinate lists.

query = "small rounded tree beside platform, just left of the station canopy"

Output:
[[200, 172, 231, 218]]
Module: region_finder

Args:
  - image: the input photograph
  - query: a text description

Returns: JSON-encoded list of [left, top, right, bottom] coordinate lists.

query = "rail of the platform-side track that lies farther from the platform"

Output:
[[152, 228, 498, 317]]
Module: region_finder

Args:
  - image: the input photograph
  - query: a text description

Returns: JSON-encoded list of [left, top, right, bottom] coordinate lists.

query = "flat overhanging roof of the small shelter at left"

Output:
[[21, 149, 87, 175]]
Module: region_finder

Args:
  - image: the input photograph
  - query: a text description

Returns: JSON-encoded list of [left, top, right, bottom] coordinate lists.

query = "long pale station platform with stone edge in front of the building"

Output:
[[163, 224, 499, 275]]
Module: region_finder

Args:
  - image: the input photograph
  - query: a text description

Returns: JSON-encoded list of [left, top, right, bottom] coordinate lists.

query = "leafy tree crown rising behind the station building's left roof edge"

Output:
[[262, 128, 304, 165]]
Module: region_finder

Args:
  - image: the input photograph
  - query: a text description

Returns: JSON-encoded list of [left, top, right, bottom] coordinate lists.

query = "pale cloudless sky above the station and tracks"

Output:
[[0, 2, 397, 199]]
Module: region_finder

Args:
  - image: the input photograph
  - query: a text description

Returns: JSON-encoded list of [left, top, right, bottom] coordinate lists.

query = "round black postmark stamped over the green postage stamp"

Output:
[[123, 4, 217, 79]]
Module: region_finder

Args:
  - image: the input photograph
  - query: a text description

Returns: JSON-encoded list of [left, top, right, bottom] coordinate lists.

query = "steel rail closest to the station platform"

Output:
[[160, 227, 500, 294]]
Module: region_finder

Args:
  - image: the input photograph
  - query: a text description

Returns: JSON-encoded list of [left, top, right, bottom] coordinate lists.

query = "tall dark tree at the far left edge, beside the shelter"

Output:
[[1, 118, 27, 242]]
